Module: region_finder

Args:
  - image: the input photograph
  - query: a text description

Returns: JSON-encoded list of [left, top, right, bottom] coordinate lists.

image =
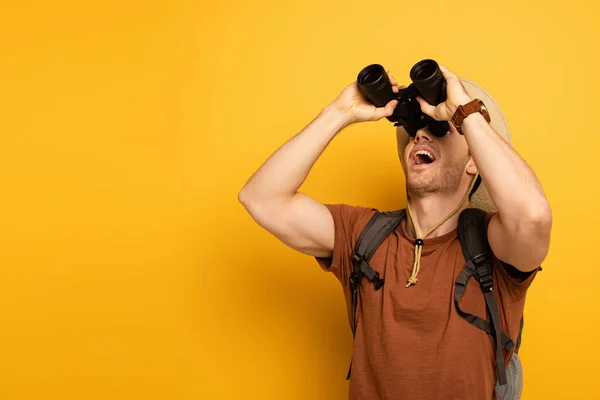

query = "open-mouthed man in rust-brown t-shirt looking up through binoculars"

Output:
[[239, 66, 552, 400]]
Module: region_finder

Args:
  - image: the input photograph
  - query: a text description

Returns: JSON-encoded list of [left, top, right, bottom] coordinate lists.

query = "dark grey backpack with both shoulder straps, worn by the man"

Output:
[[346, 208, 523, 400]]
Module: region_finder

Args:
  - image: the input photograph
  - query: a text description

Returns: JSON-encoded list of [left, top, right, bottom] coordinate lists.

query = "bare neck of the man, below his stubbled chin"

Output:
[[406, 190, 469, 238]]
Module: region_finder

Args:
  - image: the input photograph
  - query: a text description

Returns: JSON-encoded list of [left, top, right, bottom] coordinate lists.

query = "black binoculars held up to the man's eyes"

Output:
[[356, 59, 450, 137]]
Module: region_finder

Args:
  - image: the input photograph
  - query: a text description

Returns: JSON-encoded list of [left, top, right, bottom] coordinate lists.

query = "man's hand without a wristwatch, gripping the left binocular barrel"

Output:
[[329, 69, 400, 125]]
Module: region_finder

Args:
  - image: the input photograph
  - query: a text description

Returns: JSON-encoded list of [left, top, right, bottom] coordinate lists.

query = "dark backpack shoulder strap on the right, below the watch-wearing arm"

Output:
[[454, 208, 514, 385]]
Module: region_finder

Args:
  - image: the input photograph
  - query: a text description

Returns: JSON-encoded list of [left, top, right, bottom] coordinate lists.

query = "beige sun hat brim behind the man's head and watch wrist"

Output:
[[396, 78, 512, 211]]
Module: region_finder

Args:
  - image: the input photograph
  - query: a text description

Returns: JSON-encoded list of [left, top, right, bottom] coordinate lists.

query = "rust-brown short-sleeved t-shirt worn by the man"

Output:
[[317, 204, 538, 400]]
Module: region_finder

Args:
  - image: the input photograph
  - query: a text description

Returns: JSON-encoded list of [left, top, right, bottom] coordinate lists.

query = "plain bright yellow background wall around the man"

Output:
[[0, 0, 600, 400]]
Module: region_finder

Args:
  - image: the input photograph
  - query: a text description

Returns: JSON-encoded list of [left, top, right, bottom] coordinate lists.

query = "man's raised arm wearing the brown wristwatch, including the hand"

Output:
[[419, 66, 552, 272]]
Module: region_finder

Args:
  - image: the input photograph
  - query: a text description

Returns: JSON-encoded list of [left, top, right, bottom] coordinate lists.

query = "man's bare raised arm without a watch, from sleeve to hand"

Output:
[[238, 76, 399, 257]]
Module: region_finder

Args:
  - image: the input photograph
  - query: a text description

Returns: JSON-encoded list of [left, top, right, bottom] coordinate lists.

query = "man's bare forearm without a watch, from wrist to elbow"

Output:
[[239, 107, 348, 203]]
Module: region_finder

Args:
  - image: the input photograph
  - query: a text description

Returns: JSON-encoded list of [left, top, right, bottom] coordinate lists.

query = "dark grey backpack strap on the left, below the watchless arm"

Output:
[[346, 209, 406, 379]]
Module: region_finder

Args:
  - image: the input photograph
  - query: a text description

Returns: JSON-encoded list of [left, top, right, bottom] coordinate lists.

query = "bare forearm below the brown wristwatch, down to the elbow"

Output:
[[462, 113, 551, 227]]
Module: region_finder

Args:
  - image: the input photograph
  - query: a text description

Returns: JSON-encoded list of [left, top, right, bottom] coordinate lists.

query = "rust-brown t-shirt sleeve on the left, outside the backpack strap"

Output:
[[316, 204, 377, 284]]
